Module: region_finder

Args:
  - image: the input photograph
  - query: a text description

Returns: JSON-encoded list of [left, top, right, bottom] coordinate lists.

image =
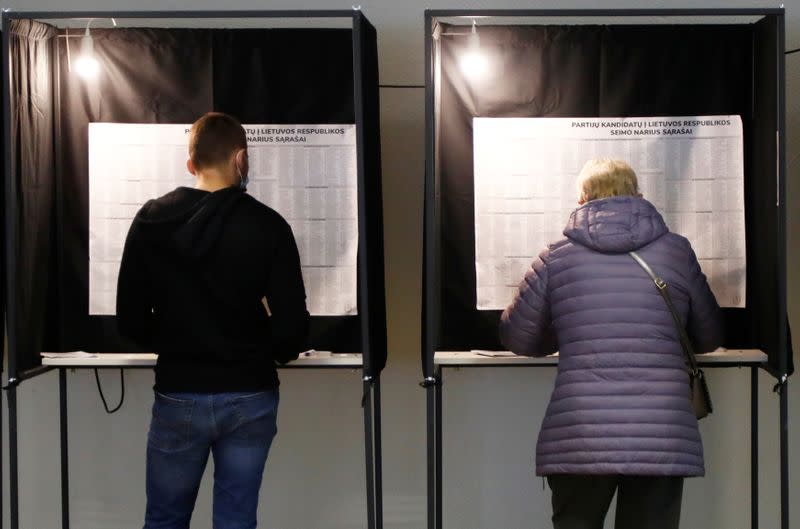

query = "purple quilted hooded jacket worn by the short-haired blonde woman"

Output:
[[500, 196, 722, 476]]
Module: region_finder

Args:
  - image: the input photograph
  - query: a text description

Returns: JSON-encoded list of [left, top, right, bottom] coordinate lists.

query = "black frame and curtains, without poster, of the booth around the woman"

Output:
[[420, 8, 793, 529]]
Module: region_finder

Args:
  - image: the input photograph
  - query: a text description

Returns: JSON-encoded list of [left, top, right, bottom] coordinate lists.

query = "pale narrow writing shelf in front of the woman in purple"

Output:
[[433, 349, 767, 367]]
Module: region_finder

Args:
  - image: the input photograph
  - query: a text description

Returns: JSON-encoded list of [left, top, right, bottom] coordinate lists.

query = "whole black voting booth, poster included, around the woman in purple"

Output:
[[421, 9, 793, 529]]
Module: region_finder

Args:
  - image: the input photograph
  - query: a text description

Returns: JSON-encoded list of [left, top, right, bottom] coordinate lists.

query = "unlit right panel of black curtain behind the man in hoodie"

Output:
[[212, 29, 361, 353]]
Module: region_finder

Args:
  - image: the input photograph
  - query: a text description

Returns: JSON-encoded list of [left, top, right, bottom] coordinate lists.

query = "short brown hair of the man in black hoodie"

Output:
[[189, 112, 247, 170]]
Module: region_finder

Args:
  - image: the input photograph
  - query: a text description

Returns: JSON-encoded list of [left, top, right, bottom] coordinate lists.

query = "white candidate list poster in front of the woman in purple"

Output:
[[473, 116, 746, 310]]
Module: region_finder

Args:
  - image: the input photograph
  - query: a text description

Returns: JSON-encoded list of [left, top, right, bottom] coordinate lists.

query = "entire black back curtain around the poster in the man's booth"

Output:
[[36, 28, 368, 365]]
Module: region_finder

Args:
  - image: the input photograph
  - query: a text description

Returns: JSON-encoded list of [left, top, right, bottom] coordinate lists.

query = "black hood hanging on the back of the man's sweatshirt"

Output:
[[133, 187, 244, 259]]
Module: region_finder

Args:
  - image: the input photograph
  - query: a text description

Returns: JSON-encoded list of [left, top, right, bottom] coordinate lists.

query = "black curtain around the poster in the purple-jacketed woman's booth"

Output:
[[429, 24, 785, 374]]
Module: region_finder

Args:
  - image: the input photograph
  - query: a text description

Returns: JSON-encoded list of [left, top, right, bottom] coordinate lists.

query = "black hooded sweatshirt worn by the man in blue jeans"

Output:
[[117, 187, 309, 393]]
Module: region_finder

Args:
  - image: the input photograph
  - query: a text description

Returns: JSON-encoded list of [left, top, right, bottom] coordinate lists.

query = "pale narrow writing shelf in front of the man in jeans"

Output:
[[42, 352, 363, 369]]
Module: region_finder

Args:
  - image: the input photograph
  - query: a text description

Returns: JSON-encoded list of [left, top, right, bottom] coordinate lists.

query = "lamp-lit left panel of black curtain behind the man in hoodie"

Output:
[[47, 28, 213, 358]]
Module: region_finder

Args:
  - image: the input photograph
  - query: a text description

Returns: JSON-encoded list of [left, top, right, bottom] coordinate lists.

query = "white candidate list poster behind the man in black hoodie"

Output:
[[89, 123, 358, 316]]
